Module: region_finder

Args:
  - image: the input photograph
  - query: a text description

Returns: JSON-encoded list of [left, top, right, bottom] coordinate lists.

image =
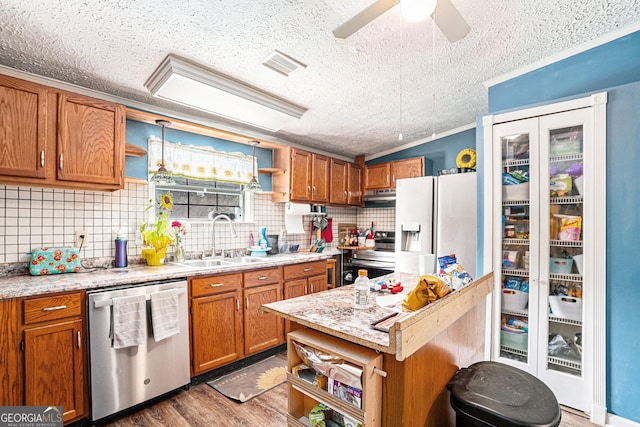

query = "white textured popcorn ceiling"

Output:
[[0, 0, 640, 157]]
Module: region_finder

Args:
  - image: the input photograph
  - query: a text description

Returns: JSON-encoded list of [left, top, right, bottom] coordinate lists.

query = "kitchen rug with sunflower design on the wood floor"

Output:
[[207, 356, 287, 403]]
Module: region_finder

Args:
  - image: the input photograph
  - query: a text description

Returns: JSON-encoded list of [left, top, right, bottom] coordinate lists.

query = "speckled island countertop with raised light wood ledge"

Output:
[[262, 273, 493, 361]]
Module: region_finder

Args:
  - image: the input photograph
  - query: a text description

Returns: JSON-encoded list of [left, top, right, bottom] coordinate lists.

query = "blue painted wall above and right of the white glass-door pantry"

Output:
[[478, 32, 640, 422]]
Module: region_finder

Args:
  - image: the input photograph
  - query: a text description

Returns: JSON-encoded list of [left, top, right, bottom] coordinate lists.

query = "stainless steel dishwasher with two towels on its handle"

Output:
[[87, 280, 191, 421]]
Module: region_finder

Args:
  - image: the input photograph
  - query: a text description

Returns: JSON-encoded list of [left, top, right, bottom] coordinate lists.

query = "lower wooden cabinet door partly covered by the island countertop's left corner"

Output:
[[244, 283, 284, 356]]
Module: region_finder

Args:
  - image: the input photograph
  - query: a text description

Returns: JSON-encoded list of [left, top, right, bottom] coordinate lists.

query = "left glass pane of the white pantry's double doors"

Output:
[[494, 115, 539, 373]]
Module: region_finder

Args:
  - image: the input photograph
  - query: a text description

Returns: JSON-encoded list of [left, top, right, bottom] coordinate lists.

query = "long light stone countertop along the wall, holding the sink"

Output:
[[0, 252, 332, 300]]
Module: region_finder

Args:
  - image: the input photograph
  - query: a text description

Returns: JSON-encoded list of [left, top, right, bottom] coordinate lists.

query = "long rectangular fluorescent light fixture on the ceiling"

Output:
[[145, 55, 307, 132]]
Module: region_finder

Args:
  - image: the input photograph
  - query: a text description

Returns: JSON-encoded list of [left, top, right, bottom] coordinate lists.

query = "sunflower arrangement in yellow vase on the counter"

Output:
[[140, 193, 174, 265]]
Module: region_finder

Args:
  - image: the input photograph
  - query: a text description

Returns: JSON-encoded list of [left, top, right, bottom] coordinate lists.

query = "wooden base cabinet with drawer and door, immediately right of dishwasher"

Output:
[[189, 273, 244, 376]]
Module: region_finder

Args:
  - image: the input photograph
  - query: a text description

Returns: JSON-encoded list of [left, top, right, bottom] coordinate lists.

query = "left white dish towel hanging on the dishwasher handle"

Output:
[[111, 295, 147, 349]]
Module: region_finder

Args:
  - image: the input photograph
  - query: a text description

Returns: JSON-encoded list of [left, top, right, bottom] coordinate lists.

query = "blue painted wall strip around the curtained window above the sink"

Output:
[[125, 120, 273, 191]]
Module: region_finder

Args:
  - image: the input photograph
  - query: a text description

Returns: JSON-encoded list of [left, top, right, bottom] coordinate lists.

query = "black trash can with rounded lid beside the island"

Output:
[[447, 362, 561, 427]]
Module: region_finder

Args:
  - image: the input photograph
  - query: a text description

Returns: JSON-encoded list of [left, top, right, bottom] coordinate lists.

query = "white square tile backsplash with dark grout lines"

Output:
[[0, 182, 395, 264]]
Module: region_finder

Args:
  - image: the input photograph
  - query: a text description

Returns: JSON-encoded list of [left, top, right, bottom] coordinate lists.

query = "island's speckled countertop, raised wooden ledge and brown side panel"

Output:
[[263, 273, 493, 427]]
